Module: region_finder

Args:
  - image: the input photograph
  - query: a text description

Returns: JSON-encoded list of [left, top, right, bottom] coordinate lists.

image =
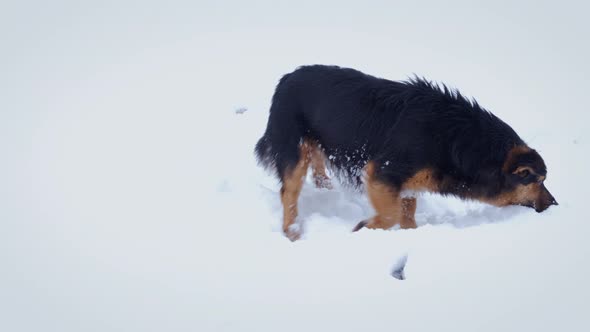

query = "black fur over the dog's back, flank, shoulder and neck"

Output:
[[256, 65, 532, 197]]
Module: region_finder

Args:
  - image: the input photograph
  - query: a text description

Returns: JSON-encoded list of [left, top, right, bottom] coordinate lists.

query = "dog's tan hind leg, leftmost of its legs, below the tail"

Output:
[[281, 142, 310, 241]]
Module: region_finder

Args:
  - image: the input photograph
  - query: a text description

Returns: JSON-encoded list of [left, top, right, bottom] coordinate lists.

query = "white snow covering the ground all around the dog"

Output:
[[0, 1, 590, 332]]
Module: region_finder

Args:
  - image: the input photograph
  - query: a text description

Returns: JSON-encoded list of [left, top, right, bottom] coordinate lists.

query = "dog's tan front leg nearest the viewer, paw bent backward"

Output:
[[353, 163, 404, 232]]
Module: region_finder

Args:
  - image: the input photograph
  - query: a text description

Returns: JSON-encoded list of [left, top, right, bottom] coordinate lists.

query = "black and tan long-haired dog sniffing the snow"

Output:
[[255, 65, 557, 241]]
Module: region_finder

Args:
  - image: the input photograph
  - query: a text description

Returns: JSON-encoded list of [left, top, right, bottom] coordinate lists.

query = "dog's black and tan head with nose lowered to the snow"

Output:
[[498, 145, 558, 212]]
